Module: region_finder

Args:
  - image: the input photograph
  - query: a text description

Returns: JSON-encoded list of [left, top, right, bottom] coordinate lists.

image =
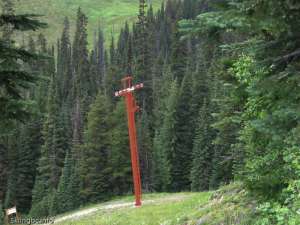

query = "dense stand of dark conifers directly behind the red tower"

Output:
[[1, 0, 223, 216]]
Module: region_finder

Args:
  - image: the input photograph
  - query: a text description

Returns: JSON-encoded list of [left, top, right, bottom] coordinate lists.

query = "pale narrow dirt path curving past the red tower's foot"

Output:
[[54, 194, 188, 224]]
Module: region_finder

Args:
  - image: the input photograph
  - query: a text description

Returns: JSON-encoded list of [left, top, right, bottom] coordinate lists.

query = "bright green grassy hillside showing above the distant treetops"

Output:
[[17, 0, 163, 44]]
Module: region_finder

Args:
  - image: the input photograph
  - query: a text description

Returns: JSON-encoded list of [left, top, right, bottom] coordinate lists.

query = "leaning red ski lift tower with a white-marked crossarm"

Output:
[[115, 76, 144, 206]]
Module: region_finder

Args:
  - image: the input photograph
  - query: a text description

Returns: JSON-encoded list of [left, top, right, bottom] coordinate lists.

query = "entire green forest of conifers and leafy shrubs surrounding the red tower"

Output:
[[0, 0, 300, 225]]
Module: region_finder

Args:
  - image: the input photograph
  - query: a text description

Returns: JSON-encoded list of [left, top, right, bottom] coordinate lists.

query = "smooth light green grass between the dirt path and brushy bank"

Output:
[[55, 192, 211, 225]]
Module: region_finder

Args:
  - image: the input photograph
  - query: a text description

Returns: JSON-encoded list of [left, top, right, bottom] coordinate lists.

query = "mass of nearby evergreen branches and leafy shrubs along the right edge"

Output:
[[182, 0, 299, 221]]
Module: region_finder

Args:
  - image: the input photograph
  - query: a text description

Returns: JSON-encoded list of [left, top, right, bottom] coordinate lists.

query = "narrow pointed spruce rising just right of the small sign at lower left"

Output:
[[32, 71, 69, 215]]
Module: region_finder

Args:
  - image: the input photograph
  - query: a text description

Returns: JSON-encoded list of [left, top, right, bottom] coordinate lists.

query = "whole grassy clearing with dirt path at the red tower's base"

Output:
[[50, 184, 256, 225]]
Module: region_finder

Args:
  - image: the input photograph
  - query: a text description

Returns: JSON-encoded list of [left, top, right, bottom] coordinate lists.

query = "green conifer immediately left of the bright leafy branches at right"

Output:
[[211, 59, 247, 188]]
